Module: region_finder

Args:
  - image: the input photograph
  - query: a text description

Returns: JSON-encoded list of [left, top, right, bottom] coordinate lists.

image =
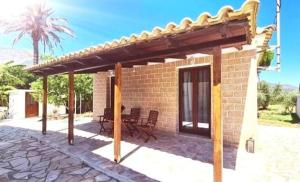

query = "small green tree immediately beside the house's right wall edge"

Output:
[[257, 81, 271, 109]]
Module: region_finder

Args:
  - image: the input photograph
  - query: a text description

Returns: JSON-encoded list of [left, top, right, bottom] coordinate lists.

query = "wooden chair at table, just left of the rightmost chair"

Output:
[[123, 108, 141, 136]]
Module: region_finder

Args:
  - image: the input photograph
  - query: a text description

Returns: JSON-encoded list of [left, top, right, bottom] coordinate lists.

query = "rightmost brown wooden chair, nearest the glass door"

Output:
[[139, 110, 158, 143]]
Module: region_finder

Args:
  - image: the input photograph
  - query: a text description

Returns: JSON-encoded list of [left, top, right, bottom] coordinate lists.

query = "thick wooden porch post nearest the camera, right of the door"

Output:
[[213, 47, 223, 182]]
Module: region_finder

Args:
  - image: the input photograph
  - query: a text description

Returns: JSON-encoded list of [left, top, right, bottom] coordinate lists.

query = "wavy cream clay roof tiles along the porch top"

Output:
[[27, 0, 259, 71]]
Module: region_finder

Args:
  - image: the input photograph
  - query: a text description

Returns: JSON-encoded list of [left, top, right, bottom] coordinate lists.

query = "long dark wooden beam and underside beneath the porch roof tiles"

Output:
[[29, 20, 249, 75]]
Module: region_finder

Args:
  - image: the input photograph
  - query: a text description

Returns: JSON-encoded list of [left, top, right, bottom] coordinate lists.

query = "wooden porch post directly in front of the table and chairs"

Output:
[[114, 63, 122, 162]]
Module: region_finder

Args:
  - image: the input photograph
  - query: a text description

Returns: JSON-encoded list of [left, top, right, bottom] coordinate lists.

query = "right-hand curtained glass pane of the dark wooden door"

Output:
[[198, 69, 210, 129]]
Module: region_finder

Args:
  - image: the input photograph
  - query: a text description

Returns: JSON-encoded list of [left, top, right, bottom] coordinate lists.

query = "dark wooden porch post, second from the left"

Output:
[[68, 72, 74, 145]]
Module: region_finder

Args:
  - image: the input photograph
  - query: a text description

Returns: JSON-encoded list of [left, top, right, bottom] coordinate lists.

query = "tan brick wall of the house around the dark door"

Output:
[[93, 50, 257, 146]]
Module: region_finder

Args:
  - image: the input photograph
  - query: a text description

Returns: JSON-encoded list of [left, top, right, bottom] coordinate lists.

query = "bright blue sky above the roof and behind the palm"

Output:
[[0, 0, 300, 86]]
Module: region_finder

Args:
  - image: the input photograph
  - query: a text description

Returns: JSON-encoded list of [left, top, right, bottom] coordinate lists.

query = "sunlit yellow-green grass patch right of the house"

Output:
[[258, 105, 300, 128]]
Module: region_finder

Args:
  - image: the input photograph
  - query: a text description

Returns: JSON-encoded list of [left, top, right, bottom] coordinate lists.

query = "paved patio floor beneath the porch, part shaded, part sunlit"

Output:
[[0, 119, 259, 181]]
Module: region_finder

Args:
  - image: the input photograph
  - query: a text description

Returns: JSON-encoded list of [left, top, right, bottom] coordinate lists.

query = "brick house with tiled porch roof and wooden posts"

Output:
[[27, 0, 274, 181]]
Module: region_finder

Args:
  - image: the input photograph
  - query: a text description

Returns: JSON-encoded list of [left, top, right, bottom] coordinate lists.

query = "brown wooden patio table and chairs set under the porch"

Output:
[[99, 107, 158, 143]]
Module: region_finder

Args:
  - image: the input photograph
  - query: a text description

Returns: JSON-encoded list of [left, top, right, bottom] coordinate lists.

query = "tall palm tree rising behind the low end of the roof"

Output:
[[5, 3, 73, 64]]
